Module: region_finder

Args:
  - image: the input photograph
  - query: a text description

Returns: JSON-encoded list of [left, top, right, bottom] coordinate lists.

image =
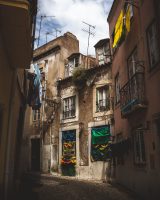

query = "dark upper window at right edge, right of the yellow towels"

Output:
[[147, 21, 160, 69]]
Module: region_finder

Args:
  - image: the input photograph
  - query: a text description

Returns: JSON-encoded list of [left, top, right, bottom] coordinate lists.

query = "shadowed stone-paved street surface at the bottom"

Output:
[[19, 173, 142, 200]]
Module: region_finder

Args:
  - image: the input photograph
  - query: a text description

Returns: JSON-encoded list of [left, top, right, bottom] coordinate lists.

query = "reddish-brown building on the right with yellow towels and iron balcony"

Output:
[[108, 0, 160, 199]]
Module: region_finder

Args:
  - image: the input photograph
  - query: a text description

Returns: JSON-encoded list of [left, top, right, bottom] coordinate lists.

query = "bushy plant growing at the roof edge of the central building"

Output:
[[72, 67, 87, 89]]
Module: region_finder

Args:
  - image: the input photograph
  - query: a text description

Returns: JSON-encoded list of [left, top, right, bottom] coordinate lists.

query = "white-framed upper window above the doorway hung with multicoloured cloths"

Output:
[[63, 96, 76, 119]]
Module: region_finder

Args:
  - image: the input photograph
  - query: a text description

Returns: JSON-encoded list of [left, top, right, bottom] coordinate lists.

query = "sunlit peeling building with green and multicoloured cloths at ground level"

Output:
[[58, 39, 113, 180]]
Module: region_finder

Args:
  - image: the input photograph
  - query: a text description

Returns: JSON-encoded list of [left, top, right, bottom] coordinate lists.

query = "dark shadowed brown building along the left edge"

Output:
[[0, 0, 37, 200]]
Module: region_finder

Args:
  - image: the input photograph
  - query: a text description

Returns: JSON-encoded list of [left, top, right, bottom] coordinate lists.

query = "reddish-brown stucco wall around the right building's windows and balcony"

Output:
[[108, 0, 160, 199]]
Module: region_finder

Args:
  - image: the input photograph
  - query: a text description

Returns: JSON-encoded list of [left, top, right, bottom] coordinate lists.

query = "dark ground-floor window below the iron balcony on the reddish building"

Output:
[[133, 130, 146, 164]]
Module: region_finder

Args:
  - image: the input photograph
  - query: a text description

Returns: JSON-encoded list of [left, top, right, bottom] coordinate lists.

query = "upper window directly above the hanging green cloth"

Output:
[[96, 86, 110, 112]]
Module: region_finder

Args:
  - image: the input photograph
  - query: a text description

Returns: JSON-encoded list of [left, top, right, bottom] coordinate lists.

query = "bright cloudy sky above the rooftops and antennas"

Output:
[[35, 0, 113, 55]]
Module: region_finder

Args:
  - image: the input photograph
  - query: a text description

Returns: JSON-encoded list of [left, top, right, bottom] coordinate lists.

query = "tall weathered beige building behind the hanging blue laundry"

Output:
[[24, 32, 79, 173]]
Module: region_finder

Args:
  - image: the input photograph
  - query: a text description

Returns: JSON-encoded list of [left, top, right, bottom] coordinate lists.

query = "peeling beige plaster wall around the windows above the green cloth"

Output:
[[59, 67, 113, 181]]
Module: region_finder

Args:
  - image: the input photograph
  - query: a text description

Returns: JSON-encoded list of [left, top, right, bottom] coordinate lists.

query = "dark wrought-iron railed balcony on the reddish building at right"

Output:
[[120, 67, 147, 118]]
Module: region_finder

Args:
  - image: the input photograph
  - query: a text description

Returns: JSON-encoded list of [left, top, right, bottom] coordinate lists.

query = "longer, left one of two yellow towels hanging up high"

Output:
[[113, 10, 124, 48]]
